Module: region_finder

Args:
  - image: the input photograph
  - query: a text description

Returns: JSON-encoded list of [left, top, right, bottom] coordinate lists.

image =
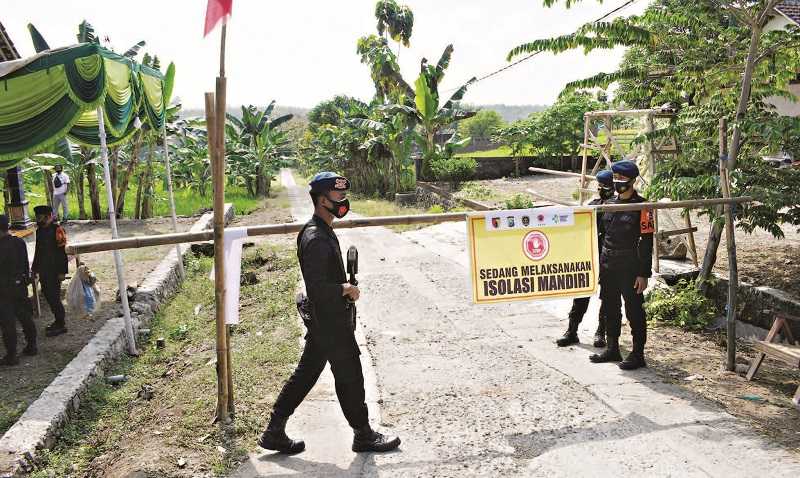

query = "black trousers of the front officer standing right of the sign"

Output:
[[600, 255, 647, 353]]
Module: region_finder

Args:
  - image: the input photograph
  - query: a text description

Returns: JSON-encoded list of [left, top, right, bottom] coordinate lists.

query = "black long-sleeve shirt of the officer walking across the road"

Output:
[[297, 215, 359, 354]]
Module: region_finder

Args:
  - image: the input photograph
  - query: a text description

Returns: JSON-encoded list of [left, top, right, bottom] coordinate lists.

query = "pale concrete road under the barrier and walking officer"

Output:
[[236, 170, 800, 477]]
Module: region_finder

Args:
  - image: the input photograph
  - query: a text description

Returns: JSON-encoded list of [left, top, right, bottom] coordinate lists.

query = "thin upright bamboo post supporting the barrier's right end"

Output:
[[719, 118, 739, 372]]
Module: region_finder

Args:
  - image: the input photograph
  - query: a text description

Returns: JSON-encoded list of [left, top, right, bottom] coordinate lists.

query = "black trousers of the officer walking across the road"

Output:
[[273, 334, 369, 428]]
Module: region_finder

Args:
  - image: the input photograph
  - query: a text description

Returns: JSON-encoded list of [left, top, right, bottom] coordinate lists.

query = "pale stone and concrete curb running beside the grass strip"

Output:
[[0, 204, 234, 478]]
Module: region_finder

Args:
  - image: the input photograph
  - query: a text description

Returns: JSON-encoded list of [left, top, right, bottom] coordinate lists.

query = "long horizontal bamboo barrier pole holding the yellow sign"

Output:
[[67, 196, 753, 254]]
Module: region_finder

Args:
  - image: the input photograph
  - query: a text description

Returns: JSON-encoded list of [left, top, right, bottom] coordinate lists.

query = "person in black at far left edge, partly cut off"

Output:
[[0, 214, 37, 365]]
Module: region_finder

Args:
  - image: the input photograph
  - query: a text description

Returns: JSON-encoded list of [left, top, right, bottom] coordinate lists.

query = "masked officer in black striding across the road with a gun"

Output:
[[258, 172, 400, 453]]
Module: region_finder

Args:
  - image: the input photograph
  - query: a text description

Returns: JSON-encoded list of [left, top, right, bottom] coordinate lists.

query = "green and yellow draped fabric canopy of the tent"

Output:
[[0, 43, 167, 169]]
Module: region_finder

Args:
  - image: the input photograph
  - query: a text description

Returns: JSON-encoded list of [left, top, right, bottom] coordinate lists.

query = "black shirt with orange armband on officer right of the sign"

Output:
[[601, 192, 655, 277]]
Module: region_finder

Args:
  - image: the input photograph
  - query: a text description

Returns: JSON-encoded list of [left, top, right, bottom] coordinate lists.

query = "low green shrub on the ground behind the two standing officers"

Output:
[[644, 280, 717, 330]]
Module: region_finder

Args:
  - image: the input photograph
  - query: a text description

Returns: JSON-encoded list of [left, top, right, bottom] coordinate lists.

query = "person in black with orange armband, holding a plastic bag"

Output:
[[31, 205, 67, 337]]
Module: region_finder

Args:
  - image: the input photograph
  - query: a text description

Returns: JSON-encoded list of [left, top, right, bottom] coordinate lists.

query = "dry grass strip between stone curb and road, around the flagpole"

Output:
[[33, 245, 301, 477]]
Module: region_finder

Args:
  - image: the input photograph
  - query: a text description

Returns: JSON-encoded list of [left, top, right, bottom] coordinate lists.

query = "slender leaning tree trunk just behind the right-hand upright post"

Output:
[[697, 0, 778, 293]]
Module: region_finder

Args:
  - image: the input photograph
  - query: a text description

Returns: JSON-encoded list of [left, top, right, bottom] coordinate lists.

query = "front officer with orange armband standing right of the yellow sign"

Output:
[[589, 160, 654, 370]]
